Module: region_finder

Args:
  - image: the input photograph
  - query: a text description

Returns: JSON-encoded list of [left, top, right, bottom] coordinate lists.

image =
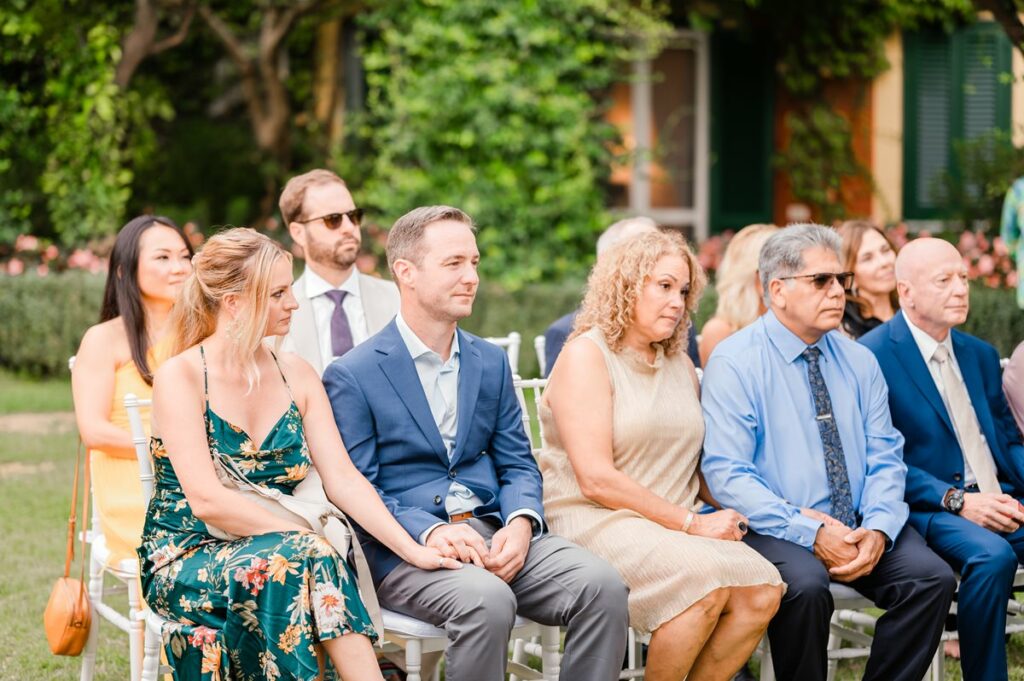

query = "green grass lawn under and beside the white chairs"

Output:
[[6, 372, 1024, 681]]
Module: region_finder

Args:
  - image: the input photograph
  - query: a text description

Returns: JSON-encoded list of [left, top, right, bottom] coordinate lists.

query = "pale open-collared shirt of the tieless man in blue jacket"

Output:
[[394, 312, 543, 544]]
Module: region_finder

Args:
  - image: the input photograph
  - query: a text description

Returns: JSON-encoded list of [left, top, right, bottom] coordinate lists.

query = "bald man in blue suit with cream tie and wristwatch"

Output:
[[860, 239, 1024, 681]]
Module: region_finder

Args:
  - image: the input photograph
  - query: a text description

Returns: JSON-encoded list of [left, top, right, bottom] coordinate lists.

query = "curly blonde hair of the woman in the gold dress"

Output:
[[569, 230, 708, 356]]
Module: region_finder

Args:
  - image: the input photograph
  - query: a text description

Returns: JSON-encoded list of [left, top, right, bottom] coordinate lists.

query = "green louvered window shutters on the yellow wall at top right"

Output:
[[903, 22, 1012, 219]]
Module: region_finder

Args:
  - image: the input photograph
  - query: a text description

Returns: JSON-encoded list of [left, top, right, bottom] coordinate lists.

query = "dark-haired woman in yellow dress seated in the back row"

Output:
[[72, 215, 193, 565]]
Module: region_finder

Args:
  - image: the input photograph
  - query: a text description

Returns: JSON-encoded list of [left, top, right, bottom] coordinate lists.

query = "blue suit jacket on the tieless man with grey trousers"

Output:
[[324, 321, 544, 584]]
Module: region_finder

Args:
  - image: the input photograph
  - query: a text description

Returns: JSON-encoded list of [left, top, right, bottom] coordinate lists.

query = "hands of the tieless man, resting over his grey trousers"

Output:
[[427, 517, 532, 582]]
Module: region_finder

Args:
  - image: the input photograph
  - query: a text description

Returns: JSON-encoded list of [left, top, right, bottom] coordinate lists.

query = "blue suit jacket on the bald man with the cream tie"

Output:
[[860, 312, 1024, 535]]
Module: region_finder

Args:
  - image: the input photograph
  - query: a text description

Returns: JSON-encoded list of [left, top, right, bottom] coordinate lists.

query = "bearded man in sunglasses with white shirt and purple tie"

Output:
[[280, 169, 398, 374]]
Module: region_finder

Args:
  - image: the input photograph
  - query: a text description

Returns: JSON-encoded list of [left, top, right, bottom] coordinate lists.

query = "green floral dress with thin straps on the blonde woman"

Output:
[[138, 347, 377, 681]]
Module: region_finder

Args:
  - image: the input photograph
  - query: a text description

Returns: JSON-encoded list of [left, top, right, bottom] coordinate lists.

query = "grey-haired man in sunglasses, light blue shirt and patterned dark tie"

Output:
[[701, 225, 955, 681]]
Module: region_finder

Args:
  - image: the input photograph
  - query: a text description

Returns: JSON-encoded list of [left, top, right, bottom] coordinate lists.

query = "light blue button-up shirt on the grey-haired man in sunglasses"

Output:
[[700, 311, 909, 549]]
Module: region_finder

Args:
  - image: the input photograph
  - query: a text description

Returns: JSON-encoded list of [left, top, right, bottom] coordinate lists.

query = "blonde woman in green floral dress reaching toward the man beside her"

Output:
[[138, 228, 461, 681]]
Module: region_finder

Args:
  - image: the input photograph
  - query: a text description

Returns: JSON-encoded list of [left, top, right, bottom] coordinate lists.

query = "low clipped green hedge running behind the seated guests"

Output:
[[0, 272, 1024, 376]]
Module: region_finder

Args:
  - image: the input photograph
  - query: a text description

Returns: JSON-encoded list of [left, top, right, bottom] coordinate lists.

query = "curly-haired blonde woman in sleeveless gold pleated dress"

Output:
[[541, 231, 784, 681]]
